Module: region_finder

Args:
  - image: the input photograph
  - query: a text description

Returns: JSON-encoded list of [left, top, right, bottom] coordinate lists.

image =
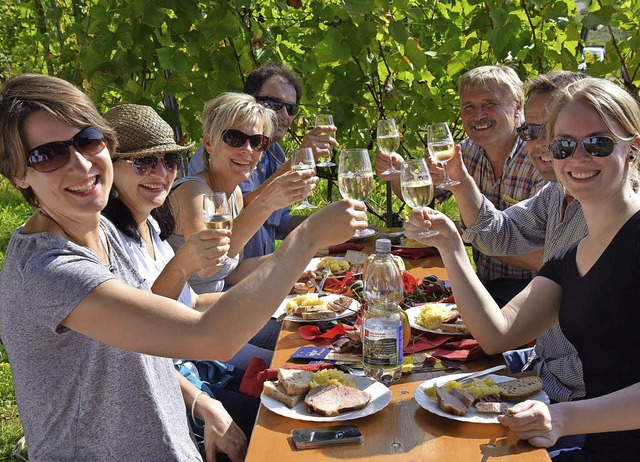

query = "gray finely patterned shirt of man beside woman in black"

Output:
[[462, 182, 588, 401]]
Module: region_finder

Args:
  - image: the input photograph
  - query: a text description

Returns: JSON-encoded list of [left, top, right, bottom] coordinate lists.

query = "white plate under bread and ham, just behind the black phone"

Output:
[[260, 374, 390, 422]]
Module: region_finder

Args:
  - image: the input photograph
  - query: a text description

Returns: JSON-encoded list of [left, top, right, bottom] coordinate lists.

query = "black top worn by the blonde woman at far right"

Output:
[[538, 212, 640, 461]]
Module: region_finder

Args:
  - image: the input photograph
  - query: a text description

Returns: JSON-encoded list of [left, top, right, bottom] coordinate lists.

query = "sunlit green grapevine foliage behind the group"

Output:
[[0, 0, 640, 149]]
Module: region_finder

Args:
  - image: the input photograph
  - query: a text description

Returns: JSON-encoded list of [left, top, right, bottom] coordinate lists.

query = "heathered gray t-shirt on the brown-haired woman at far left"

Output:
[[0, 218, 202, 462]]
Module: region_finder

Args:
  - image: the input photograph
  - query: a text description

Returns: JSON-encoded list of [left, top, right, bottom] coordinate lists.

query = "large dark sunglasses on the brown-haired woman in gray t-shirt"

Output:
[[27, 127, 106, 173]]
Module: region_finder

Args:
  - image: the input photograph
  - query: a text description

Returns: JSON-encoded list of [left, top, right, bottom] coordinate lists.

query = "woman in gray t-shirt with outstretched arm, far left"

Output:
[[0, 74, 366, 461]]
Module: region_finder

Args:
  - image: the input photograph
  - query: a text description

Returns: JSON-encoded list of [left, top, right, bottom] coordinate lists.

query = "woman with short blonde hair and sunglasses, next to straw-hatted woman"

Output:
[[169, 92, 318, 293]]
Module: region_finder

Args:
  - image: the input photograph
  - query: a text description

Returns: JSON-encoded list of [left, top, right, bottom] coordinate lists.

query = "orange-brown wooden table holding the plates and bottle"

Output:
[[246, 238, 550, 462]]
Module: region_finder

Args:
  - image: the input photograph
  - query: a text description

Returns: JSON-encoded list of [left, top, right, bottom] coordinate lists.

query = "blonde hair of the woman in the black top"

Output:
[[547, 77, 640, 192]]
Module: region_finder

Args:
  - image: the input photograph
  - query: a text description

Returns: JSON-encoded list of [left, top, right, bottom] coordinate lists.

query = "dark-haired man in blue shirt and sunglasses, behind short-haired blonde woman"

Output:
[[189, 64, 338, 258]]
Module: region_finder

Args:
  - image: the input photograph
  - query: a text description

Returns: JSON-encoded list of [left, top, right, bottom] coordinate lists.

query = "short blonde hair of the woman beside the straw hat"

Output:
[[202, 92, 278, 168]]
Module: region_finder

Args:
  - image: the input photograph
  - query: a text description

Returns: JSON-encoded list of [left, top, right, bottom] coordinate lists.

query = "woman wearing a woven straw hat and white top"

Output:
[[103, 104, 272, 460]]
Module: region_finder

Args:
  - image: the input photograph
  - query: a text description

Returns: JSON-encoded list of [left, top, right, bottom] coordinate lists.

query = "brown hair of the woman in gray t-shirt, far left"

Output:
[[0, 74, 116, 207]]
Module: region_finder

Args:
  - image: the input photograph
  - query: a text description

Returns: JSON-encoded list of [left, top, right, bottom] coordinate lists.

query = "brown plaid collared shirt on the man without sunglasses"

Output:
[[460, 138, 546, 283]]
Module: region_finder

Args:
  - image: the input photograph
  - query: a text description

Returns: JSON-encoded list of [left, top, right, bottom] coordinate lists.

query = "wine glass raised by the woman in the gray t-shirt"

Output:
[[338, 149, 373, 238]]
